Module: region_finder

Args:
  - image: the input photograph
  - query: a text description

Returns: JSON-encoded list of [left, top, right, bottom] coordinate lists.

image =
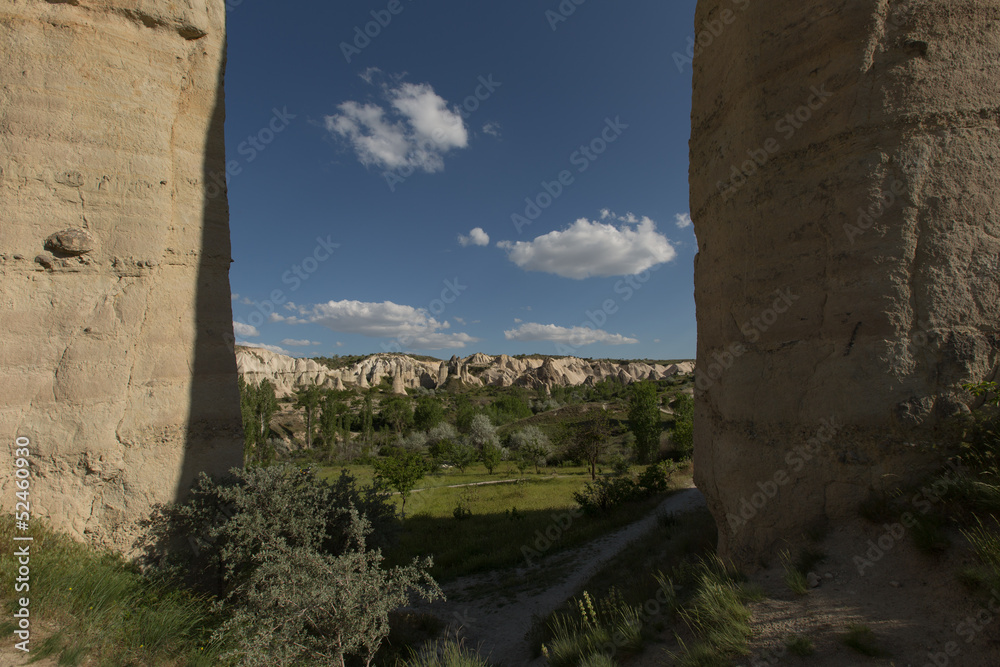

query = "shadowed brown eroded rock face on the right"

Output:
[[691, 0, 1000, 563]]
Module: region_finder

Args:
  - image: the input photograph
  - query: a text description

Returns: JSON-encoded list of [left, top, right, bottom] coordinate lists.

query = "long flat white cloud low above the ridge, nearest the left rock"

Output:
[[271, 301, 479, 350]]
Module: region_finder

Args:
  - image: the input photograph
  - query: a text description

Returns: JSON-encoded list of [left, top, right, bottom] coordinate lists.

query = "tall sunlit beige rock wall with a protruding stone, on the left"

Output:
[[0, 0, 242, 549]]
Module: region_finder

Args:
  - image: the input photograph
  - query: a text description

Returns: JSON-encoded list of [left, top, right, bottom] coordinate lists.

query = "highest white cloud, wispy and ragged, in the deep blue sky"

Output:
[[324, 79, 469, 173]]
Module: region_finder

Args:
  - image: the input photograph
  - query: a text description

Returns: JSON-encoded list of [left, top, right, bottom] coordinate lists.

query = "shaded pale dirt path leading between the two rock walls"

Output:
[[421, 488, 705, 666]]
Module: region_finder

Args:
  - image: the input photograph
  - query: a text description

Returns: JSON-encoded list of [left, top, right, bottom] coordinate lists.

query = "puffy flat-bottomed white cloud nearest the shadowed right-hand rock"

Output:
[[497, 217, 677, 280]]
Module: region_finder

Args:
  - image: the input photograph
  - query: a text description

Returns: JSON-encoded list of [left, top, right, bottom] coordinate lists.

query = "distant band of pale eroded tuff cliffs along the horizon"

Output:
[[236, 346, 694, 397]]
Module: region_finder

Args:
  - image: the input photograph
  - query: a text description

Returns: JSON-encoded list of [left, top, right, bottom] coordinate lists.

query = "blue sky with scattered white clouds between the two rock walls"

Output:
[[226, 0, 697, 359]]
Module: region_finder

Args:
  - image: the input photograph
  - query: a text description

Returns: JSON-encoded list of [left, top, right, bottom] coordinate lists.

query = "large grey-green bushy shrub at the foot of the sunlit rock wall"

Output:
[[143, 465, 432, 666]]
